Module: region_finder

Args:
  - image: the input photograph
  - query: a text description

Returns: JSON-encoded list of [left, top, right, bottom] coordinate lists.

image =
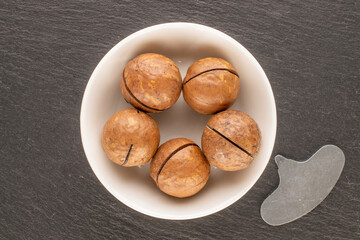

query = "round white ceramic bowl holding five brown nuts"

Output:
[[80, 23, 276, 219]]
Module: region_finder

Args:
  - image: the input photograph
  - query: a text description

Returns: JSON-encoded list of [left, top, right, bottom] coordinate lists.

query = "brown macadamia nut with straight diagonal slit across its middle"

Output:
[[201, 110, 261, 171]]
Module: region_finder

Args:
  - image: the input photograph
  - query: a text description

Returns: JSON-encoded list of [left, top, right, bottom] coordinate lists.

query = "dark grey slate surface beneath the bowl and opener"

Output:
[[0, 0, 360, 239]]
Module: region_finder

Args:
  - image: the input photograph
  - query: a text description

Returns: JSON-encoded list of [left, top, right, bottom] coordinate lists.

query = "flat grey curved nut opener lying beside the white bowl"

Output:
[[260, 145, 345, 226]]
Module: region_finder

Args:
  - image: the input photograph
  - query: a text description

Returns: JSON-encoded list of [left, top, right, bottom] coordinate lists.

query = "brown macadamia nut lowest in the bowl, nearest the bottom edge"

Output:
[[150, 138, 210, 198]]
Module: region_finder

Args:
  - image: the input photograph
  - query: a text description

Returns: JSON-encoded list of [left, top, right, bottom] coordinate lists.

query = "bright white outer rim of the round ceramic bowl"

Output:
[[80, 22, 277, 220]]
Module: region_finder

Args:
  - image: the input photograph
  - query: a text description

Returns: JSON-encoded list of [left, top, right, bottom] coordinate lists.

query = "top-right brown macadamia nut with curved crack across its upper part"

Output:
[[183, 57, 240, 114]]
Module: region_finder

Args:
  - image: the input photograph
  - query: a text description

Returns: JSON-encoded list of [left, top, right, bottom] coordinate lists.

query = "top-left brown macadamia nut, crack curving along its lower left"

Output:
[[120, 53, 182, 112]]
